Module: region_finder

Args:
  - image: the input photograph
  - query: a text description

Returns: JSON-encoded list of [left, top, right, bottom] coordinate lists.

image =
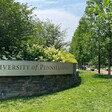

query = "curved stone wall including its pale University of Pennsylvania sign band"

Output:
[[0, 61, 80, 99]]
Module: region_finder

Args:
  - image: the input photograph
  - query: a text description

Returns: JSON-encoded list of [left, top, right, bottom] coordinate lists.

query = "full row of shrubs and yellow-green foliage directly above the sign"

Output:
[[0, 44, 77, 63]]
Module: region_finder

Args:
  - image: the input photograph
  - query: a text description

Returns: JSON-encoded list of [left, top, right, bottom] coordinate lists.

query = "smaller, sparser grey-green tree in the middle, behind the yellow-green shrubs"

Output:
[[36, 20, 67, 49]]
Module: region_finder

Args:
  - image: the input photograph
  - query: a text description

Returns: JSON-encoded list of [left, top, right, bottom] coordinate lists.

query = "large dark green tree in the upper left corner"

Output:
[[0, 0, 34, 52]]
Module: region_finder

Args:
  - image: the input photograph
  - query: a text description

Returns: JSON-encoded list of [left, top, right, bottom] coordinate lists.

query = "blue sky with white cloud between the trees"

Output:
[[16, 0, 86, 41]]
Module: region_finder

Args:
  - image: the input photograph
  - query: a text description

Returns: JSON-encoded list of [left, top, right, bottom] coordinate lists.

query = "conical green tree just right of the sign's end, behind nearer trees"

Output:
[[70, 17, 93, 67]]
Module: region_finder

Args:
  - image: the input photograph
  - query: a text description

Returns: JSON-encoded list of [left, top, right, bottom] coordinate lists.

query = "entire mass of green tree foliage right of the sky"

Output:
[[70, 0, 112, 69]]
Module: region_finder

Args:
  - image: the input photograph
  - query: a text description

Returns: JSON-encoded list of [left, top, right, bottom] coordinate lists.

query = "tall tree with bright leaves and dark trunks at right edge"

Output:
[[85, 0, 112, 75]]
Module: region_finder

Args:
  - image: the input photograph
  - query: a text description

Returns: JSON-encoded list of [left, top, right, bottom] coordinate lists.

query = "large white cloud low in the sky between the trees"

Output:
[[34, 9, 80, 41]]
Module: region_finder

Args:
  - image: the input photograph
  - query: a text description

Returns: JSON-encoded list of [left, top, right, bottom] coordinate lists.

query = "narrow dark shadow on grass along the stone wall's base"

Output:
[[0, 77, 81, 103]]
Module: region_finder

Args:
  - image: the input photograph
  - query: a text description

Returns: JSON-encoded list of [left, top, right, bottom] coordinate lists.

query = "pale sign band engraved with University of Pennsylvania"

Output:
[[0, 61, 74, 76]]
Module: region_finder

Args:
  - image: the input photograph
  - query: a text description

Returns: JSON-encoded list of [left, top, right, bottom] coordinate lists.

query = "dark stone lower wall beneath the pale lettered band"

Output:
[[0, 73, 80, 99]]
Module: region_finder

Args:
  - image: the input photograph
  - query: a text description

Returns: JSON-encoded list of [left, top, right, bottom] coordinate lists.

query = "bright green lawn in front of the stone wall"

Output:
[[0, 71, 112, 112]]
